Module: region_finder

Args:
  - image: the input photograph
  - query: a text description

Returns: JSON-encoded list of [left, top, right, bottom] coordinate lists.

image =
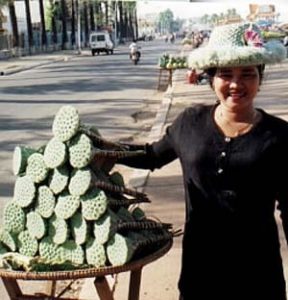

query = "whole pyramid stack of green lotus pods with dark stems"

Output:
[[0, 105, 172, 271]]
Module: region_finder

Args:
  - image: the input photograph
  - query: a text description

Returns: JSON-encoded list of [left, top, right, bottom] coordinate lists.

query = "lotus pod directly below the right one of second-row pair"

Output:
[[68, 168, 92, 196]]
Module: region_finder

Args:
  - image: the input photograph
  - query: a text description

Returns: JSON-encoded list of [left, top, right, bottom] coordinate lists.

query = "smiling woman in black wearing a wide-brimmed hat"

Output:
[[121, 24, 288, 300]]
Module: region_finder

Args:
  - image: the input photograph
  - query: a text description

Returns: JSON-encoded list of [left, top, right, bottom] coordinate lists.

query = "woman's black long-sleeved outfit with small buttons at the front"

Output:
[[121, 105, 288, 300]]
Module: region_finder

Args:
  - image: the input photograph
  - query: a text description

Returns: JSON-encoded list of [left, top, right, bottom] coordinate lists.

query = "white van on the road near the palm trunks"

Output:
[[89, 31, 114, 56]]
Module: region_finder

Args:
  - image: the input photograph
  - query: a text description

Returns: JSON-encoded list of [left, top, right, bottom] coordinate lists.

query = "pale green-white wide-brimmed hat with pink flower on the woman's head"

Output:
[[188, 23, 287, 69]]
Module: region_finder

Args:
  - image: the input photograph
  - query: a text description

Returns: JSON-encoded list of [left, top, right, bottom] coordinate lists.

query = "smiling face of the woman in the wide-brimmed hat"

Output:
[[213, 66, 260, 110]]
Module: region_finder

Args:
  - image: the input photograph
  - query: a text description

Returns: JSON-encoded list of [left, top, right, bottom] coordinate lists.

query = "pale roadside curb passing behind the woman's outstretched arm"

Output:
[[128, 70, 179, 192]]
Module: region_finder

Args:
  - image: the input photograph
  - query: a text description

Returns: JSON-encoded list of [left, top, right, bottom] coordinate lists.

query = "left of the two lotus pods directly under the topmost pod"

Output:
[[44, 138, 67, 169]]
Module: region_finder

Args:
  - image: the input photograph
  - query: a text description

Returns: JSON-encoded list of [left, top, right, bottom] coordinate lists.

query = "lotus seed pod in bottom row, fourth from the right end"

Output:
[[39, 236, 62, 263]]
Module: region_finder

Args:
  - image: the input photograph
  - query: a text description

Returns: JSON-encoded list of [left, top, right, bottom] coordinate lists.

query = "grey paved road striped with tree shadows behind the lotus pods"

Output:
[[0, 41, 178, 209]]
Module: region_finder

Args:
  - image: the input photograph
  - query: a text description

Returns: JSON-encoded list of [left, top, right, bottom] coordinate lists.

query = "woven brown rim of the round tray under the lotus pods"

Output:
[[0, 239, 173, 280]]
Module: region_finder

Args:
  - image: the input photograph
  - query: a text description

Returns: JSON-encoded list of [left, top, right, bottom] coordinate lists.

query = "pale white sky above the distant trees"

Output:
[[137, 0, 288, 22]]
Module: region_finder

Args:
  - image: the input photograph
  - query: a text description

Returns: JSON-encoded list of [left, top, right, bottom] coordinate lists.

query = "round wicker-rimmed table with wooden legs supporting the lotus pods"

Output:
[[0, 239, 172, 300]]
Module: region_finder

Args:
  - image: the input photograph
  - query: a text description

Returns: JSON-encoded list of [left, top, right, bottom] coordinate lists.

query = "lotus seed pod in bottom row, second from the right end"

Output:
[[85, 238, 107, 268]]
